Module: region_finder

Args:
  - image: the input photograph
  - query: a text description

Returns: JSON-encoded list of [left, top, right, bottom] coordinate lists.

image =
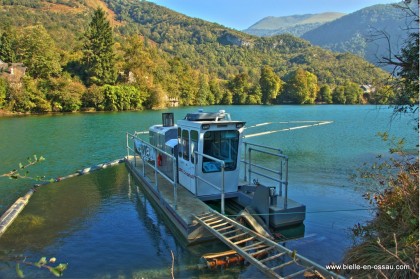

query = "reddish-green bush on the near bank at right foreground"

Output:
[[345, 134, 419, 278]]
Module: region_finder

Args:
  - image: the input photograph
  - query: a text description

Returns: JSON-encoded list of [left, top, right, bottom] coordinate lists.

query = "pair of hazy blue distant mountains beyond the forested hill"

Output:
[[244, 1, 418, 70]]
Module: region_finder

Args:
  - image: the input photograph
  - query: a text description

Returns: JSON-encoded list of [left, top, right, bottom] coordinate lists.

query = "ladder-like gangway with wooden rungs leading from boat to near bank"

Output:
[[194, 211, 344, 278]]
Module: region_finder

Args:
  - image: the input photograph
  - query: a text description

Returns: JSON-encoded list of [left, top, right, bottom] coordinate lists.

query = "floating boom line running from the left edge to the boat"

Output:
[[0, 158, 125, 237]]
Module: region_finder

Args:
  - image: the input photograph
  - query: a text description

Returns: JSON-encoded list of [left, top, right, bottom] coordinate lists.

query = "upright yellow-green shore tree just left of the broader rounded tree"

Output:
[[260, 66, 281, 105]]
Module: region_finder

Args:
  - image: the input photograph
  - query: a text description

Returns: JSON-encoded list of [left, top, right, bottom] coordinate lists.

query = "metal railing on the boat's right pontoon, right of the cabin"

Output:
[[241, 142, 289, 209]]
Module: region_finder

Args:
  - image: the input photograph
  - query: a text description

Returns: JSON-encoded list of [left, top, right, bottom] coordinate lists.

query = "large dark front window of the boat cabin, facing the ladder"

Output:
[[203, 130, 239, 173]]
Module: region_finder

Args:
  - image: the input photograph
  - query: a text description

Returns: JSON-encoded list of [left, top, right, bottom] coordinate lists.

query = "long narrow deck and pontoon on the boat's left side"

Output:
[[126, 156, 213, 244]]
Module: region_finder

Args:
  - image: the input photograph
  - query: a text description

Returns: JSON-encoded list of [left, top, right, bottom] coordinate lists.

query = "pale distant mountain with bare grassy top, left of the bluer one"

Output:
[[243, 12, 345, 37]]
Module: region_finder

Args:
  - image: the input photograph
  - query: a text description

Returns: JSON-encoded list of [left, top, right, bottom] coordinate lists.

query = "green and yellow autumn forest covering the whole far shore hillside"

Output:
[[0, 0, 396, 113]]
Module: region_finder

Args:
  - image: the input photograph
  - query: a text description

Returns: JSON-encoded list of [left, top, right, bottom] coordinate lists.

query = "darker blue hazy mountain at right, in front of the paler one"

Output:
[[301, 1, 418, 69]]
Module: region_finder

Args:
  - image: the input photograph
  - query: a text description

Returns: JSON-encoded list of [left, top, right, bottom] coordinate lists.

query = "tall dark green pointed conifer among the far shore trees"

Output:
[[83, 8, 116, 85]]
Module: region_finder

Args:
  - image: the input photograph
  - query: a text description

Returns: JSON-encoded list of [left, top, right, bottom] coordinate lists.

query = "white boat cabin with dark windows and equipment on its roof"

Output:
[[149, 110, 245, 199]]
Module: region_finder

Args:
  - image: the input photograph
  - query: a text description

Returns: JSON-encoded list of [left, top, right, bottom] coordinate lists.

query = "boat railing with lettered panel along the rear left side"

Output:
[[126, 133, 178, 209]]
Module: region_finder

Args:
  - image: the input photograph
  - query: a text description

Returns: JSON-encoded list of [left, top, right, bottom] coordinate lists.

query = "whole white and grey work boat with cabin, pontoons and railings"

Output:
[[126, 110, 306, 243]]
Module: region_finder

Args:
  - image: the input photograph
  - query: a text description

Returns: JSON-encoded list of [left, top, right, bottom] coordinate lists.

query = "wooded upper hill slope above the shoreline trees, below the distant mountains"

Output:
[[108, 2, 388, 82]]
